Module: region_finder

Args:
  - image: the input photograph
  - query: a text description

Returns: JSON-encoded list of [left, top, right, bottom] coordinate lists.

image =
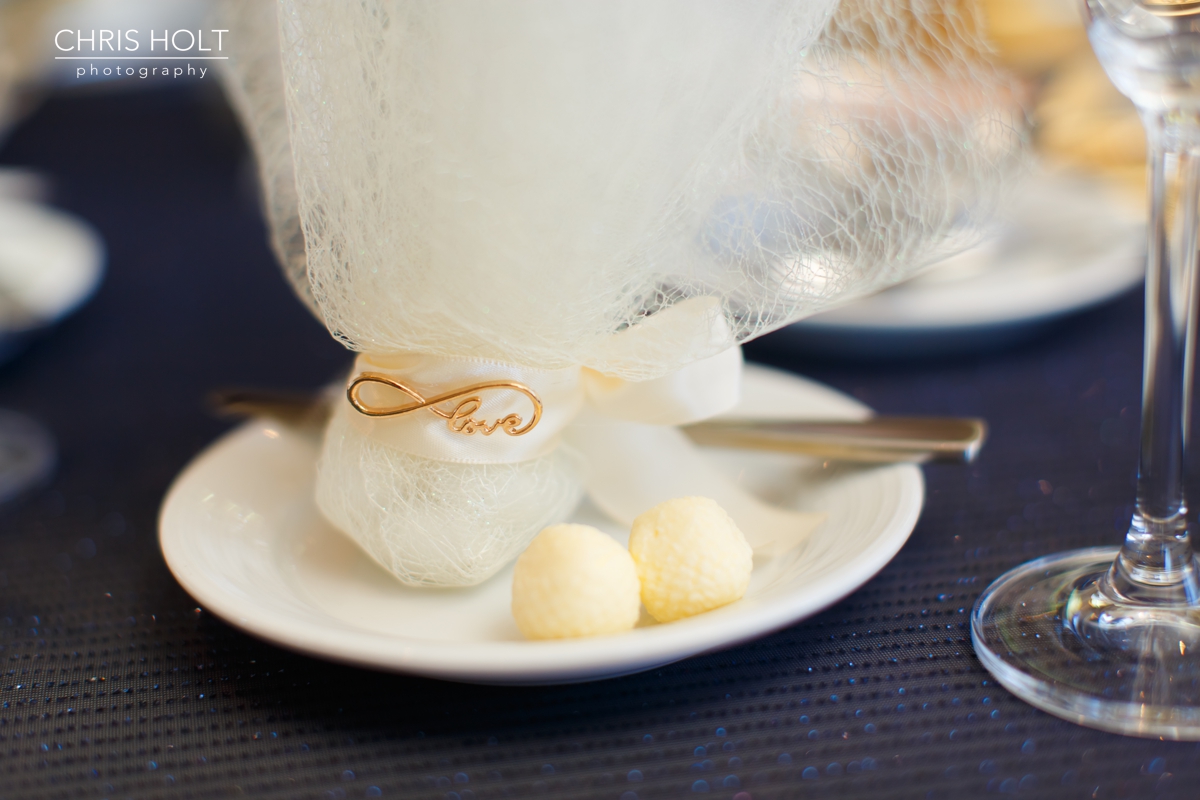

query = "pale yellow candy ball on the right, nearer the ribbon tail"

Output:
[[629, 498, 754, 622]]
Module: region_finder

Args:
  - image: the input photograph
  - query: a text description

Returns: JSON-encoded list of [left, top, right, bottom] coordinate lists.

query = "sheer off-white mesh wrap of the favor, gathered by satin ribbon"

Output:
[[218, 0, 1019, 585]]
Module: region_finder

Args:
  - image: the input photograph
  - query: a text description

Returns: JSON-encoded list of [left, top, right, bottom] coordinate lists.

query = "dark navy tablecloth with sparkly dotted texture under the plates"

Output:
[[0, 82, 1180, 800]]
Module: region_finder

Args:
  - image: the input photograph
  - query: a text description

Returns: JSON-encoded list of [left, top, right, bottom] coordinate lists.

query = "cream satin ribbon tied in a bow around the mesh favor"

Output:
[[335, 299, 824, 557]]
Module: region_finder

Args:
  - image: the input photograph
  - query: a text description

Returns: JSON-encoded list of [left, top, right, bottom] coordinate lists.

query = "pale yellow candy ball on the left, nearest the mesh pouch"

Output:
[[512, 524, 640, 639]]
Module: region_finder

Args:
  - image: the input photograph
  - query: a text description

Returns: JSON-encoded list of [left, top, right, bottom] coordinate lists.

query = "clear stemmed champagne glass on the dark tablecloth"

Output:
[[971, 0, 1200, 740]]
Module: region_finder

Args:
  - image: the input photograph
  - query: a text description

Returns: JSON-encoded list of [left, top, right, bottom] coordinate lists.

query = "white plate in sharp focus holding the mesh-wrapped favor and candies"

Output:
[[158, 367, 924, 684]]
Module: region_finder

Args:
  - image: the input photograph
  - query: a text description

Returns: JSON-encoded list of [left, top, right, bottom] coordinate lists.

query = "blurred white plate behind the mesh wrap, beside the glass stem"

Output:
[[782, 170, 1146, 355]]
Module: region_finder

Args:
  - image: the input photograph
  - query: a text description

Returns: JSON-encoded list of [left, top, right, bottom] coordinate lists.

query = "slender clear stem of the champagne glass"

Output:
[[1103, 110, 1200, 606]]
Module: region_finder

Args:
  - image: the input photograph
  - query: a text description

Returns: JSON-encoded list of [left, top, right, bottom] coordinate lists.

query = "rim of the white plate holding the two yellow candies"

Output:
[[158, 371, 924, 685]]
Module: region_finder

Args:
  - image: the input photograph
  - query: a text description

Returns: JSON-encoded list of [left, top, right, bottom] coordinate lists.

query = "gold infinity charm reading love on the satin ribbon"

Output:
[[346, 372, 541, 437]]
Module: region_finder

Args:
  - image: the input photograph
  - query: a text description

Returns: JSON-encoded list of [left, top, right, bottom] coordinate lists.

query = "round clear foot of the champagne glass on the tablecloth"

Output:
[[971, 547, 1200, 740]]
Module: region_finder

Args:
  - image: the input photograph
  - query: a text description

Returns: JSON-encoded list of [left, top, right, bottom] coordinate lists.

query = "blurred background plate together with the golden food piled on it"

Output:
[[775, 0, 1146, 357]]
